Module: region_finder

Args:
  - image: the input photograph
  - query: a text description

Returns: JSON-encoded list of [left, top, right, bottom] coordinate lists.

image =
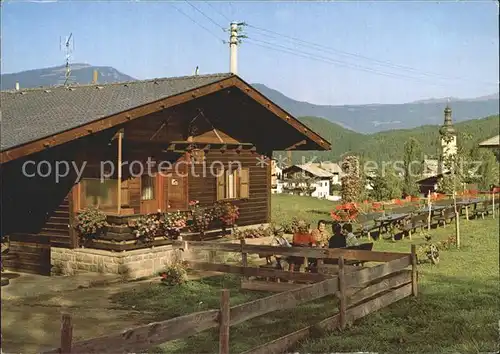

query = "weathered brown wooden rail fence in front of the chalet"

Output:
[[44, 241, 418, 354]]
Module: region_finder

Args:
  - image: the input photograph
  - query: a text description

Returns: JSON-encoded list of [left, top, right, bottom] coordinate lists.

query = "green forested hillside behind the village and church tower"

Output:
[[284, 116, 500, 162]]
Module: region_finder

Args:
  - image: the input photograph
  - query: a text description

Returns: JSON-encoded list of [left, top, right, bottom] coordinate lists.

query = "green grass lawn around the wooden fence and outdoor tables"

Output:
[[114, 195, 500, 353]]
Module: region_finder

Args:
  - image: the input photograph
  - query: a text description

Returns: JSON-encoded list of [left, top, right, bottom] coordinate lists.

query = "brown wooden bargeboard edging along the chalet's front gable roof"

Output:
[[0, 75, 331, 163]]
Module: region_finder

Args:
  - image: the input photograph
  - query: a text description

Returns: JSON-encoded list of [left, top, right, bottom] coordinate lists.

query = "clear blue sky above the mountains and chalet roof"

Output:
[[1, 0, 499, 105]]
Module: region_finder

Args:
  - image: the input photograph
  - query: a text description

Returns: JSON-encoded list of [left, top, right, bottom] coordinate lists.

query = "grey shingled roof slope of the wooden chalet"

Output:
[[0, 74, 232, 151]]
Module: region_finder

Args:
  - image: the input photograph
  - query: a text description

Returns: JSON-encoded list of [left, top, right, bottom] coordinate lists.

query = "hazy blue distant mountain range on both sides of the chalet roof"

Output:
[[1, 63, 499, 134]]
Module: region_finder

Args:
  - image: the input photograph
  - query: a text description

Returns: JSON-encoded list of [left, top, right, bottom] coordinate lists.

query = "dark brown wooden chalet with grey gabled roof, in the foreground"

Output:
[[1, 74, 330, 274]]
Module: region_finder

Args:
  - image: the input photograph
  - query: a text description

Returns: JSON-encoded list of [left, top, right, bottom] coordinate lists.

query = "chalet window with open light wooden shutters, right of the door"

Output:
[[217, 168, 250, 200]]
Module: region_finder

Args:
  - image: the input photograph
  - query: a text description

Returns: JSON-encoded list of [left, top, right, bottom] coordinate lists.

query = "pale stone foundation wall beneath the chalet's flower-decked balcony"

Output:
[[51, 245, 181, 279]]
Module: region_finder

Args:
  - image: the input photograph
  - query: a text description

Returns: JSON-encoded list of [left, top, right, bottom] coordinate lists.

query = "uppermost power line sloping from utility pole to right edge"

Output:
[[248, 24, 498, 86]]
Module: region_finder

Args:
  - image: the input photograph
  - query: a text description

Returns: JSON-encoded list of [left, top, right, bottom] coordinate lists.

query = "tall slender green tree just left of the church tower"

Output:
[[402, 138, 422, 196]]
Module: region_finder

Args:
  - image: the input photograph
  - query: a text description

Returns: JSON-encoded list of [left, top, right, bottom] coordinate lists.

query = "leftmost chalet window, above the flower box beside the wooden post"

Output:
[[80, 178, 118, 210]]
